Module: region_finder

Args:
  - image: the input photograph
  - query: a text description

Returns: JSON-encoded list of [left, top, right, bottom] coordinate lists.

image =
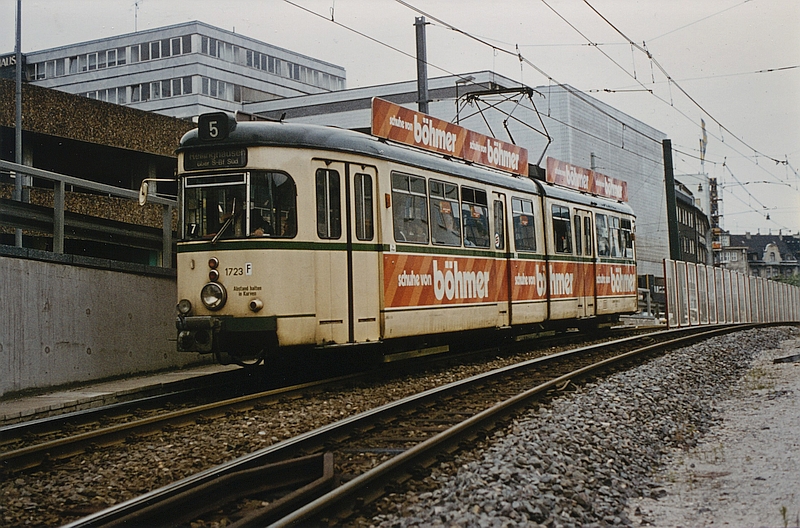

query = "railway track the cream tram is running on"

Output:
[[0, 329, 643, 473]]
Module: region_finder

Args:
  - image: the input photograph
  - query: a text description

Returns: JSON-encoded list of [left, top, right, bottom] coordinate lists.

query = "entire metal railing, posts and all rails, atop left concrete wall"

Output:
[[0, 160, 177, 268]]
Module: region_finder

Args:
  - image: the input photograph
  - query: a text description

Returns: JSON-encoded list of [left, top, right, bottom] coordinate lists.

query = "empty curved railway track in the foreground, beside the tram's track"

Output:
[[62, 325, 755, 528]]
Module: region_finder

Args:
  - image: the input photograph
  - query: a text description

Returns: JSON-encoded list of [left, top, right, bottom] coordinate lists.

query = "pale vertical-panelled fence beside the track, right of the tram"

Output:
[[664, 260, 800, 328]]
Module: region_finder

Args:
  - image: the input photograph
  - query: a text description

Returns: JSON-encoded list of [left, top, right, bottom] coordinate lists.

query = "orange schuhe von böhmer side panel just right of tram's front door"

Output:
[[383, 253, 508, 308]]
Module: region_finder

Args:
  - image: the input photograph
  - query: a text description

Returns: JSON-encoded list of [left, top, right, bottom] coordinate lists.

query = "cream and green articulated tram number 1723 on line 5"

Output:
[[176, 113, 637, 364]]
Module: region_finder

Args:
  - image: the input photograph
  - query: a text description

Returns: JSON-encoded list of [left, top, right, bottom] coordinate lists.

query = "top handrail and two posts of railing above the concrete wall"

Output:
[[0, 160, 178, 268]]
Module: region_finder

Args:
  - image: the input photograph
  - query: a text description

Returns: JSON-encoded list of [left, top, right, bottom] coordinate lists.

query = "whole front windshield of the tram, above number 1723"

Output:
[[184, 171, 297, 240]]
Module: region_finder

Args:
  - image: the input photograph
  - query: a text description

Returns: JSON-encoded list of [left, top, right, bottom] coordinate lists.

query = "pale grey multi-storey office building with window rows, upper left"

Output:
[[9, 22, 346, 118]]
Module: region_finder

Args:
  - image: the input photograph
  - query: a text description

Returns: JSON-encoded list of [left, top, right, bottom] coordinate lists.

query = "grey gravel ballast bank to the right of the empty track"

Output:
[[366, 328, 800, 527]]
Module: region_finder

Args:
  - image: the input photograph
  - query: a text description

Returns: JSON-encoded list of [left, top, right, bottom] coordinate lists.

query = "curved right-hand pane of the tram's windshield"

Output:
[[247, 172, 297, 238]]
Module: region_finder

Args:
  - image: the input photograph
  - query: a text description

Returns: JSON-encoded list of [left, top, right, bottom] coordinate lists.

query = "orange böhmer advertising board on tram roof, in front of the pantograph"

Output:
[[372, 97, 528, 176]]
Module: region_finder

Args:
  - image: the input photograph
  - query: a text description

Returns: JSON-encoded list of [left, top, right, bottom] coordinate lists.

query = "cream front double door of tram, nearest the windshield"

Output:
[[313, 160, 380, 345]]
